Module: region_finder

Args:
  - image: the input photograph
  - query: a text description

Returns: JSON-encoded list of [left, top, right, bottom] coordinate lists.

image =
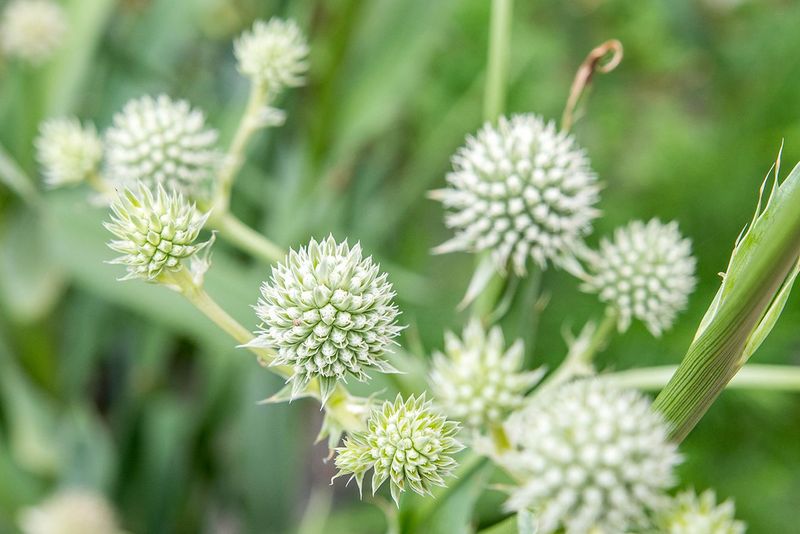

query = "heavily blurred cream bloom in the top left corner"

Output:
[[0, 0, 67, 65]]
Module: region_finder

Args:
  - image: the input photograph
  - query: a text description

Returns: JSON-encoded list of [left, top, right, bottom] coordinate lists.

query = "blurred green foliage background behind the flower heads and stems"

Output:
[[0, 0, 800, 534]]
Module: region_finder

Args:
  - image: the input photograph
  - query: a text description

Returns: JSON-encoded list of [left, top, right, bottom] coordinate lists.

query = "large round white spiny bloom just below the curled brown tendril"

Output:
[[431, 114, 600, 274]]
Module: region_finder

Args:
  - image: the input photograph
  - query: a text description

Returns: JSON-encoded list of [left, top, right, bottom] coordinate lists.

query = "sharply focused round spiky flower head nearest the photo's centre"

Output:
[[254, 236, 401, 402]]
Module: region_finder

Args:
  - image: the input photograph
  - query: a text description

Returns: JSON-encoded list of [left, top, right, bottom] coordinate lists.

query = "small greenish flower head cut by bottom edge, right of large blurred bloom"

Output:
[[657, 489, 746, 534]]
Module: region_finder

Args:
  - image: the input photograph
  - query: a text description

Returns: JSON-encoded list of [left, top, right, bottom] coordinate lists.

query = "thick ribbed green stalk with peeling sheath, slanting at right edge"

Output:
[[654, 160, 800, 442]]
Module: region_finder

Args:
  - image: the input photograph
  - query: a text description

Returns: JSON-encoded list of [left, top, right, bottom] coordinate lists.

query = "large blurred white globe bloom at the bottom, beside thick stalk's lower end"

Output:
[[501, 379, 679, 534]]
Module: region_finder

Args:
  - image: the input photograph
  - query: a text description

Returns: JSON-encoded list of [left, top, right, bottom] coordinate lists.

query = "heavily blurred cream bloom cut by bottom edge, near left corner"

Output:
[[19, 489, 122, 534]]
